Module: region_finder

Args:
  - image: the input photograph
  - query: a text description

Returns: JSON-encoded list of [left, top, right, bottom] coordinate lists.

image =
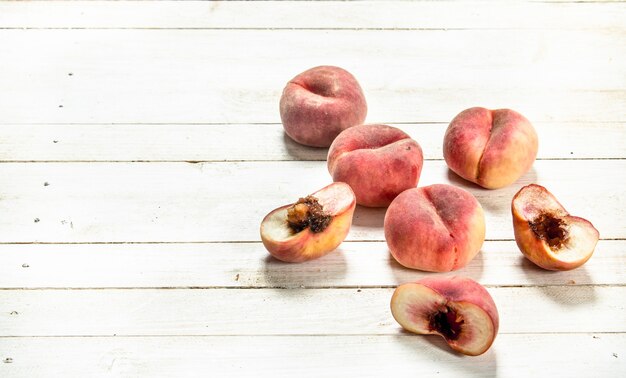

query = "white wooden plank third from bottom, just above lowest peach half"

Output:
[[0, 240, 626, 289]]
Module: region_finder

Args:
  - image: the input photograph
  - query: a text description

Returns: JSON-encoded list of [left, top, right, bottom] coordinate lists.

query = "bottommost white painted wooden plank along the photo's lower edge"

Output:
[[0, 333, 626, 378]]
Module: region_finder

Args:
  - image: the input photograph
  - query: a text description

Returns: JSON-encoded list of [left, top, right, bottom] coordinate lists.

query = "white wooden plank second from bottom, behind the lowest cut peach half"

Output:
[[0, 286, 626, 336]]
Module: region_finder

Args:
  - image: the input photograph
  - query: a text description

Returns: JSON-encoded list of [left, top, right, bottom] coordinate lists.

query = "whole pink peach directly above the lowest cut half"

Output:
[[384, 184, 485, 272]]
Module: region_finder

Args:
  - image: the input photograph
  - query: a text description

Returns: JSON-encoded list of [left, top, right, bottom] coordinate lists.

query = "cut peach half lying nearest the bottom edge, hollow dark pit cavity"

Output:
[[391, 276, 499, 356]]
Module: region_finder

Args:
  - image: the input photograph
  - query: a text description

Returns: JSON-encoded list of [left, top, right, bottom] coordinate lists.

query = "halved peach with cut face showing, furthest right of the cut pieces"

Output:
[[511, 184, 600, 270]]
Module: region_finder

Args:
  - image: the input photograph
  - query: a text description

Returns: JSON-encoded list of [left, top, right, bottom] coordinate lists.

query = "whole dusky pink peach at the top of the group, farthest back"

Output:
[[280, 66, 367, 147]]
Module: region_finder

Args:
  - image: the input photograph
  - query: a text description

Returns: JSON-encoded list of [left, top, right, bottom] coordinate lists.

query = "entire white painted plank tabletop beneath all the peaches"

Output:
[[0, 1, 626, 377]]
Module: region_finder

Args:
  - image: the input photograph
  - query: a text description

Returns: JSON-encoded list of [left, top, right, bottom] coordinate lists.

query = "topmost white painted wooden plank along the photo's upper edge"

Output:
[[0, 1, 626, 29]]
